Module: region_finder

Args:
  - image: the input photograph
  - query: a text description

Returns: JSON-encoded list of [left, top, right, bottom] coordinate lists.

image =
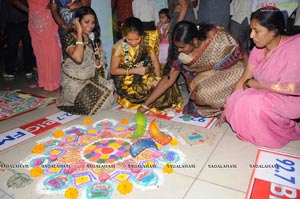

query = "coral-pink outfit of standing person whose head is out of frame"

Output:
[[28, 0, 62, 91]]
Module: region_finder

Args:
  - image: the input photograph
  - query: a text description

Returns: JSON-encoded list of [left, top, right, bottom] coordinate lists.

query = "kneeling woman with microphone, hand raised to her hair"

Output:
[[57, 6, 112, 115]]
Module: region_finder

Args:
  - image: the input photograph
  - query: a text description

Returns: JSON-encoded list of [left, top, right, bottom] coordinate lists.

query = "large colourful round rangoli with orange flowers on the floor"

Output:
[[21, 115, 184, 199]]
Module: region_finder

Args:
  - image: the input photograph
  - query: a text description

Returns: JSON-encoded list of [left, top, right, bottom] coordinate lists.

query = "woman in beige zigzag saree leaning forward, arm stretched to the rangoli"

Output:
[[139, 21, 244, 117]]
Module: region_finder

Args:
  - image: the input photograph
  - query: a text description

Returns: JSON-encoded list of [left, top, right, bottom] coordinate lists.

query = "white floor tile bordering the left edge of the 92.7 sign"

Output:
[[199, 135, 257, 192]]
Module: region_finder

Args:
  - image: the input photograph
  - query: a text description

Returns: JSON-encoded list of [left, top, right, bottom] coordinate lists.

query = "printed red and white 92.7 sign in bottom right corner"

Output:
[[246, 149, 300, 199]]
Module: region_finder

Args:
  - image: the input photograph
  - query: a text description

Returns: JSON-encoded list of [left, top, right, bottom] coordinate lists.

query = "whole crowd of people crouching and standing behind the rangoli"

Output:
[[0, 0, 300, 148]]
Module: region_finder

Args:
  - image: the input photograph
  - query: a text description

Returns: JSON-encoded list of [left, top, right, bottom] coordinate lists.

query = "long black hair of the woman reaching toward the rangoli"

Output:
[[164, 21, 214, 75]]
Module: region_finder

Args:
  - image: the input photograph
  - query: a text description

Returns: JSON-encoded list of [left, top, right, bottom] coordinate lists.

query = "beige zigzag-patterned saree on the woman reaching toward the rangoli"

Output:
[[184, 27, 245, 117]]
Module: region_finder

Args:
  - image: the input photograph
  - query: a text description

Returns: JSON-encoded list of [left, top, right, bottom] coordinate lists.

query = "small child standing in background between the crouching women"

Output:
[[157, 8, 170, 65]]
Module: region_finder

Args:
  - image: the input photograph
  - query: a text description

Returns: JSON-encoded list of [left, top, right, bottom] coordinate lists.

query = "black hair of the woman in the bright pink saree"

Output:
[[251, 7, 287, 36]]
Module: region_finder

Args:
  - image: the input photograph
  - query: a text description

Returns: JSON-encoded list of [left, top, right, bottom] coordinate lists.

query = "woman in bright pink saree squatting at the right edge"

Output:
[[226, 8, 300, 148]]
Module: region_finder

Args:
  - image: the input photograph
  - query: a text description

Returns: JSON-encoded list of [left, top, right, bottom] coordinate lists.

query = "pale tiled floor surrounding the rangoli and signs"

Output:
[[0, 75, 300, 199]]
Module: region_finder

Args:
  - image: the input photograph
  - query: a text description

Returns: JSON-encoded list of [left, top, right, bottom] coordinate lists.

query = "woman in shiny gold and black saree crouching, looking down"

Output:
[[110, 17, 182, 112]]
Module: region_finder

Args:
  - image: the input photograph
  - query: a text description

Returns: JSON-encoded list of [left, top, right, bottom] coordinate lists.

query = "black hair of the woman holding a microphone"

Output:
[[75, 6, 101, 44]]
